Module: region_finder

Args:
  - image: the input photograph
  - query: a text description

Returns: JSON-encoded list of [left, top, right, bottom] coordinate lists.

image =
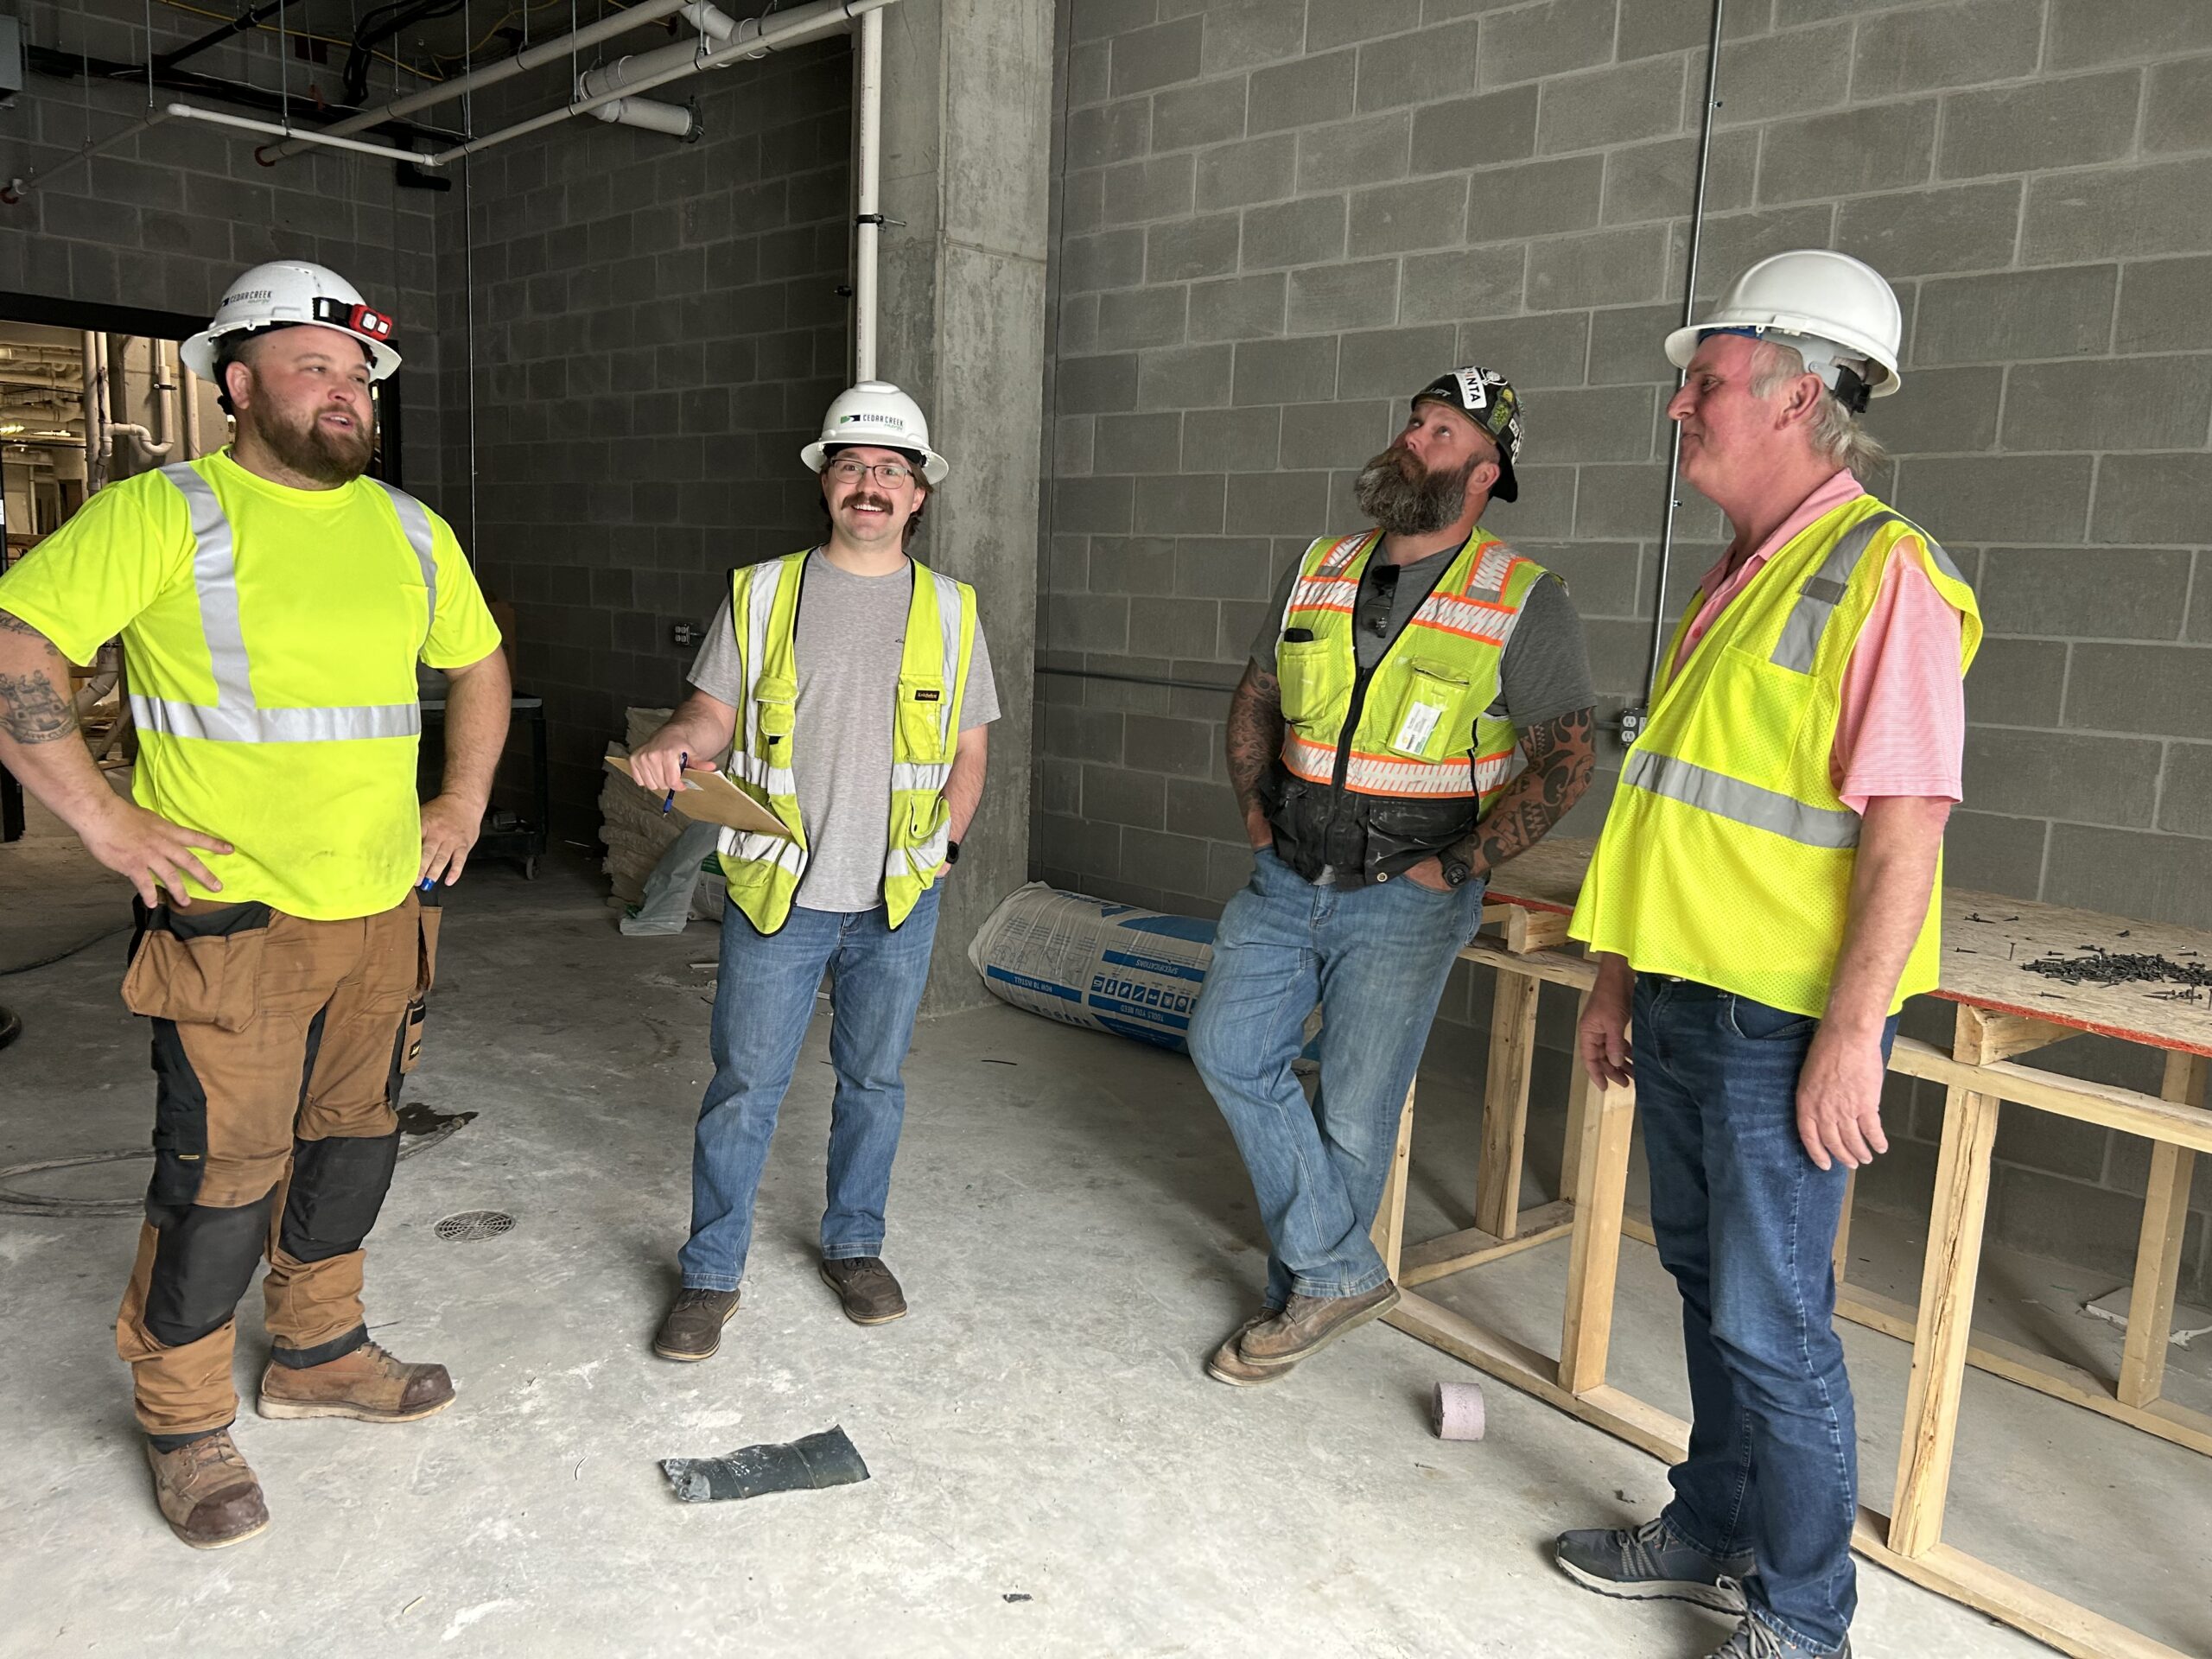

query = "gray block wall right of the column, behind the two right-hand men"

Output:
[[1033, 0, 2212, 1289]]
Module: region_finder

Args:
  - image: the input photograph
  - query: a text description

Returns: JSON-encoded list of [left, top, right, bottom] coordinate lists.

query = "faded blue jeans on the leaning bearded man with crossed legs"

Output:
[[1190, 849, 1482, 1307]]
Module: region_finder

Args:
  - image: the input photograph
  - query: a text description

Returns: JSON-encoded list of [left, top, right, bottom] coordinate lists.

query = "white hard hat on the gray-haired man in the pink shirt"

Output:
[[1666, 248, 1904, 398]]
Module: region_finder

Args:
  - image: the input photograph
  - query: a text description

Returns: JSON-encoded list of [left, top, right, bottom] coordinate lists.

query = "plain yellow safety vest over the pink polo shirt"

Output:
[[1568, 495, 1982, 1018]]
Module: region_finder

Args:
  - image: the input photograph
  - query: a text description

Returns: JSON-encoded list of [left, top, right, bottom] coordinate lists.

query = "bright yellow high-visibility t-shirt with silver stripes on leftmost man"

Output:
[[0, 449, 500, 920]]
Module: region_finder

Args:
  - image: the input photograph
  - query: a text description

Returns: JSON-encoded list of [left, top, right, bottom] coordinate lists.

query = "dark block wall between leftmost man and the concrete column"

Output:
[[438, 38, 852, 841]]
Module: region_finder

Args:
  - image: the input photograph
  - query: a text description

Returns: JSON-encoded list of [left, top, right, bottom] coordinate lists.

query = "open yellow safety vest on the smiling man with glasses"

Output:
[[721, 553, 976, 933]]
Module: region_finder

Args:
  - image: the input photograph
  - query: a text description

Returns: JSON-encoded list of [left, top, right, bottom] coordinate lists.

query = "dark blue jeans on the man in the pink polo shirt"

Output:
[[1630, 973, 1897, 1652]]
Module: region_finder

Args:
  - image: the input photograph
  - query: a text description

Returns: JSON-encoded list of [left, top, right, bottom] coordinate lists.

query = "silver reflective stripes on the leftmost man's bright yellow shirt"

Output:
[[143, 462, 438, 743]]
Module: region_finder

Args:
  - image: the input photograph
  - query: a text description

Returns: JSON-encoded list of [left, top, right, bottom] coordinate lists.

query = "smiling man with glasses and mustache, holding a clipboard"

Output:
[[631, 380, 998, 1360]]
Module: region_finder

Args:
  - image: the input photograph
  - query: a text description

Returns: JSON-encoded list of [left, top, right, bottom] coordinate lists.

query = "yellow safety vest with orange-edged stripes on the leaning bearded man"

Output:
[[1274, 529, 1546, 812]]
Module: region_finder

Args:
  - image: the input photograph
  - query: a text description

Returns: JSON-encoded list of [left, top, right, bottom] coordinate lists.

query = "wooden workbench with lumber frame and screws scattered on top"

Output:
[[1376, 841, 2212, 1659]]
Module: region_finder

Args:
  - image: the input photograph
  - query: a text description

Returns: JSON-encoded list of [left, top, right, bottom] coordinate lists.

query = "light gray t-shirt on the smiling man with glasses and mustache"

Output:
[[690, 559, 998, 912]]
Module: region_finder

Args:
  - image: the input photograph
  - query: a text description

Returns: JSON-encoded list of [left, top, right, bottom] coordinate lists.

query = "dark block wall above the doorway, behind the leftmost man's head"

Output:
[[0, 0, 451, 493]]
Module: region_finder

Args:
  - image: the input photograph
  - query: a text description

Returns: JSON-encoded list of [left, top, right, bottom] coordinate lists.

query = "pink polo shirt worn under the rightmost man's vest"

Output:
[[1675, 471, 1967, 812]]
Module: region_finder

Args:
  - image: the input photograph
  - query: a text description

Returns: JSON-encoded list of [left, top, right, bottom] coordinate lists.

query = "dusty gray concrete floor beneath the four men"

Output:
[[0, 821, 2212, 1659]]
